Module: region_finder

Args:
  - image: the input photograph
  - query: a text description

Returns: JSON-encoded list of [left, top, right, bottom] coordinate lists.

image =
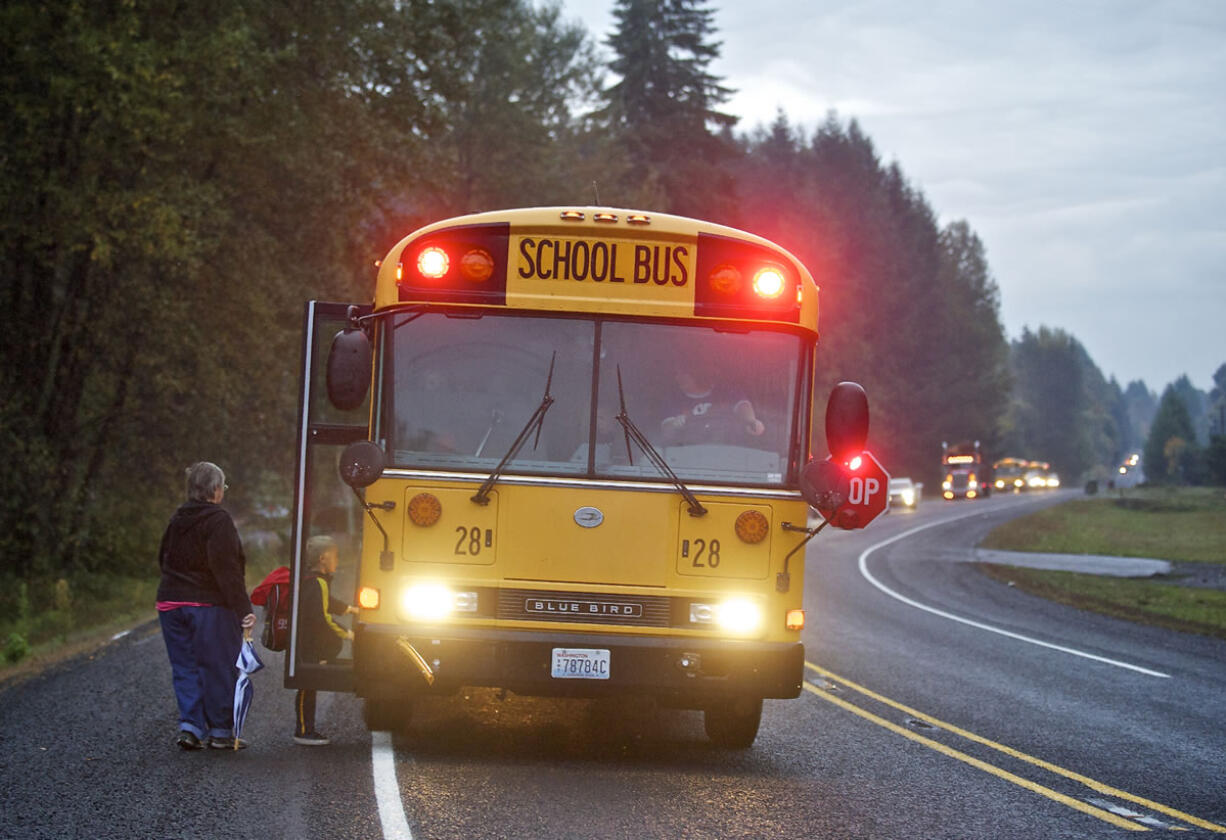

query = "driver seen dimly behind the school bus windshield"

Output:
[[660, 364, 766, 444]]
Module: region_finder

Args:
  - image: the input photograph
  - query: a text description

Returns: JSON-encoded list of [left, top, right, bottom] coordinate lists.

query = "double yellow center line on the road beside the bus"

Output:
[[804, 662, 1226, 834]]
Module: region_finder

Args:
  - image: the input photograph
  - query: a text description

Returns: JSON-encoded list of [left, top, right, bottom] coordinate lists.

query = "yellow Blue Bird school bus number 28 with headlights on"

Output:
[[286, 207, 868, 747]]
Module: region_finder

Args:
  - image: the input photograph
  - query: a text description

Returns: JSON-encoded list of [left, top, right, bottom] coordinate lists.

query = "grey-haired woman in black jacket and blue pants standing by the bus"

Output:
[[157, 461, 255, 749]]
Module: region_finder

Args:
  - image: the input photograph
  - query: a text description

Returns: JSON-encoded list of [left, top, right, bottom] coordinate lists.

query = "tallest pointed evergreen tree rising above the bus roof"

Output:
[[602, 0, 736, 218]]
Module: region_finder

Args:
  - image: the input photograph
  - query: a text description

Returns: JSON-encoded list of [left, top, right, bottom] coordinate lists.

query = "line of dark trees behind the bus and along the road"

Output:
[[0, 0, 1221, 588]]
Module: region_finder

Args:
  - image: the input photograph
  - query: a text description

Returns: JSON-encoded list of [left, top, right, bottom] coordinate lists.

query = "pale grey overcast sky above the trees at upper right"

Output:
[[562, 0, 1226, 392]]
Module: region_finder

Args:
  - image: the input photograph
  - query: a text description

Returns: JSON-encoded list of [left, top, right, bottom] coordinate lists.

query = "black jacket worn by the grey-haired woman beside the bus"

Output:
[[157, 502, 251, 618]]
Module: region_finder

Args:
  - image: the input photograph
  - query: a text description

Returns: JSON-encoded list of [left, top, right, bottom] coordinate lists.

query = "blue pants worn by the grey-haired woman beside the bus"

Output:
[[158, 607, 243, 738]]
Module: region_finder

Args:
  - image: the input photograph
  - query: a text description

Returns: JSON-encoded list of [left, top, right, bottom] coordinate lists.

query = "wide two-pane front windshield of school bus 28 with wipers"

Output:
[[381, 313, 805, 486]]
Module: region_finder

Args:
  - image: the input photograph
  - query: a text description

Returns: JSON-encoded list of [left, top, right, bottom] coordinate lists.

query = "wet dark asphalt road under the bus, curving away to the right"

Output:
[[0, 495, 1226, 840]]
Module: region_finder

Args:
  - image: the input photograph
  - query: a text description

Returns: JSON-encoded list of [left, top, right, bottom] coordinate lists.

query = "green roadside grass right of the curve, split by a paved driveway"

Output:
[[981, 487, 1226, 639]]
